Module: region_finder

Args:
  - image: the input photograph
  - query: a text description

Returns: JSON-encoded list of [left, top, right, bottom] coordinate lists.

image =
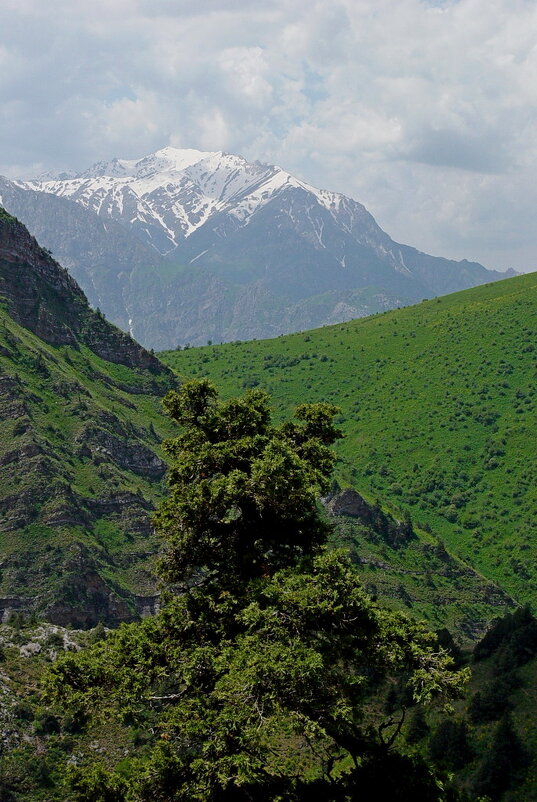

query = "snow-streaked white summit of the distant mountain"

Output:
[[23, 146, 362, 253]]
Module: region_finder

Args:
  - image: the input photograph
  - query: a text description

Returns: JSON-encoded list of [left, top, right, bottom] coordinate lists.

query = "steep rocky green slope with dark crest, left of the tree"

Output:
[[0, 210, 173, 626]]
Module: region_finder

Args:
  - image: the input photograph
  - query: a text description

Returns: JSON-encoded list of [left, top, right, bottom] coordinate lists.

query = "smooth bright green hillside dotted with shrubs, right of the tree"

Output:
[[160, 274, 537, 602]]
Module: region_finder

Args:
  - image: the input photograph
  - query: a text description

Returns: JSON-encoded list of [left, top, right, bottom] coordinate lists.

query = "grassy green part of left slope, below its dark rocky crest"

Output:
[[0, 309, 172, 617]]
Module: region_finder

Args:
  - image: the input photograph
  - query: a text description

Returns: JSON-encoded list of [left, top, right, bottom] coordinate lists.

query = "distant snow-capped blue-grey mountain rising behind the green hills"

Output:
[[0, 148, 514, 349]]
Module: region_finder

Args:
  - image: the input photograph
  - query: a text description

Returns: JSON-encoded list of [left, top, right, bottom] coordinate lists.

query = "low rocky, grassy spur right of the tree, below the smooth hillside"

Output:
[[327, 490, 514, 644]]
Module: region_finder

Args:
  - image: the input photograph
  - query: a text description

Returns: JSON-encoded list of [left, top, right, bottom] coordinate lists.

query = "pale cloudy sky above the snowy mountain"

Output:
[[0, 0, 537, 270]]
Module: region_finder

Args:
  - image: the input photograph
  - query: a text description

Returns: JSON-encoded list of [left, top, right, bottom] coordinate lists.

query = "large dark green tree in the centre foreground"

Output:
[[48, 381, 461, 802]]
